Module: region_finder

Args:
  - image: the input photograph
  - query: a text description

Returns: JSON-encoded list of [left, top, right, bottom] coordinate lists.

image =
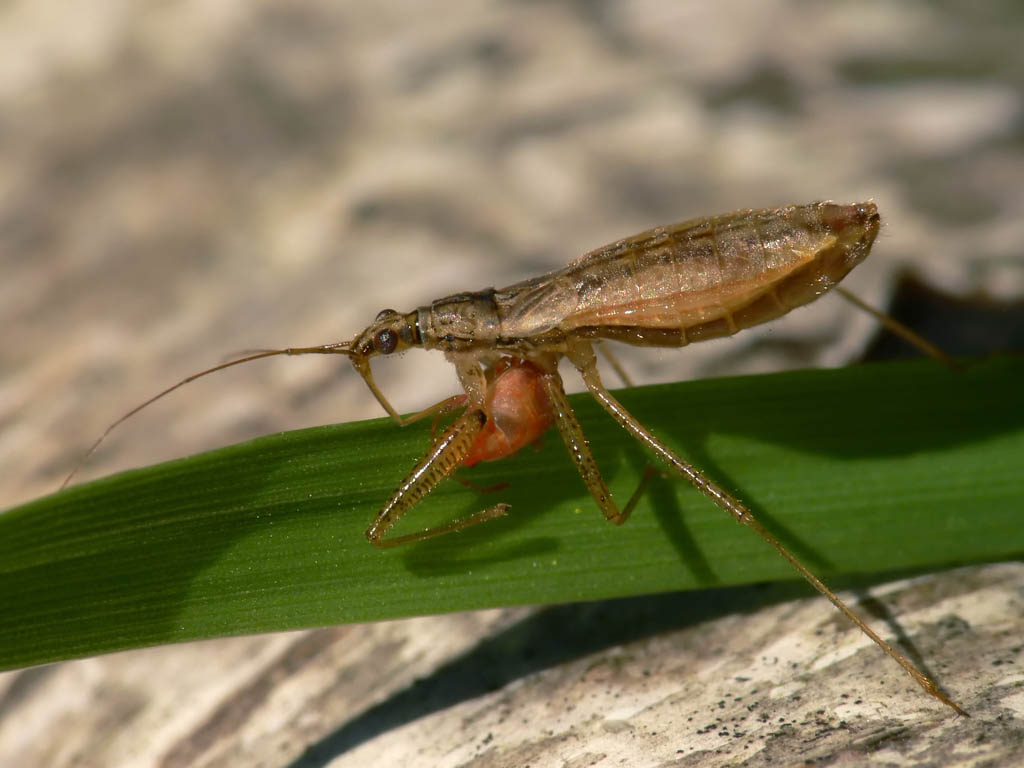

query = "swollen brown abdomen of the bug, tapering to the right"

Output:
[[553, 202, 879, 346]]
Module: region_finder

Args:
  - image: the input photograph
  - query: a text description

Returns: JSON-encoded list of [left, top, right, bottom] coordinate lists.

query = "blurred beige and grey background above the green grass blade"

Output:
[[0, 0, 1024, 765]]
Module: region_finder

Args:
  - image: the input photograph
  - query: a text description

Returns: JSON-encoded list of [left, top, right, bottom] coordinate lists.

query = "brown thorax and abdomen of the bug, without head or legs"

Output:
[[411, 203, 879, 355]]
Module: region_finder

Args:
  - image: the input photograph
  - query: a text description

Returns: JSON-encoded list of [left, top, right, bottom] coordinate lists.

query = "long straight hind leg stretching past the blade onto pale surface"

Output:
[[568, 341, 967, 715]]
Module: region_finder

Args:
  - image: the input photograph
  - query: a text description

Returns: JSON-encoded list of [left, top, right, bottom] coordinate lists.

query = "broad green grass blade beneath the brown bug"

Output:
[[0, 358, 1024, 669]]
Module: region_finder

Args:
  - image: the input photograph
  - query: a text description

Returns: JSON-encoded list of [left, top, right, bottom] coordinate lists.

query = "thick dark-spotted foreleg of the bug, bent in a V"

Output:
[[367, 410, 509, 549]]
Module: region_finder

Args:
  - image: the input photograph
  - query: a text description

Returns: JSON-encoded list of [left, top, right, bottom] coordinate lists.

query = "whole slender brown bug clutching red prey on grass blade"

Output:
[[61, 202, 966, 715]]
